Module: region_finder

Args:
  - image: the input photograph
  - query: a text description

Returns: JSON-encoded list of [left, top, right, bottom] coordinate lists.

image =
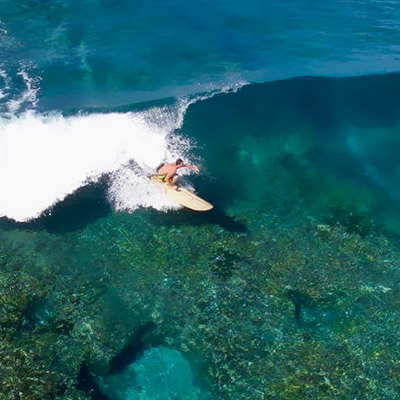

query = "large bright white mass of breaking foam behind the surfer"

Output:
[[0, 105, 195, 221]]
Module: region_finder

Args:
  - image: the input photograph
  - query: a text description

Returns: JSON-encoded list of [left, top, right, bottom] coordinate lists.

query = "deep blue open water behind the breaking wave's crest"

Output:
[[0, 0, 400, 109]]
